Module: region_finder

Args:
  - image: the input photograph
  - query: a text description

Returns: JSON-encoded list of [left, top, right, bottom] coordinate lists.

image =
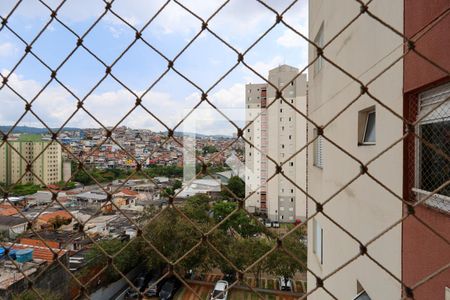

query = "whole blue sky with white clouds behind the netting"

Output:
[[0, 0, 308, 134]]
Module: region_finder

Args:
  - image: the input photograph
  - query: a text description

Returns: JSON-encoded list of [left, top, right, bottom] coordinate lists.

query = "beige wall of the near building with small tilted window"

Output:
[[308, 0, 403, 300]]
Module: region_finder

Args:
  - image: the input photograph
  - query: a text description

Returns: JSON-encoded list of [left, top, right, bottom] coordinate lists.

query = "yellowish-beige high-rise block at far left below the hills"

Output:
[[0, 141, 63, 185]]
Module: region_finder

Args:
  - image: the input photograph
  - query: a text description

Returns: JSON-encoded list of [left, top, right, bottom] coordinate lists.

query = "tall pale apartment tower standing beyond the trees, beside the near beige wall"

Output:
[[244, 65, 306, 222]]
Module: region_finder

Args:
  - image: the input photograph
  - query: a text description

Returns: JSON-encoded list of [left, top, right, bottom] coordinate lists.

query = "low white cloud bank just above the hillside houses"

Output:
[[0, 70, 245, 134]]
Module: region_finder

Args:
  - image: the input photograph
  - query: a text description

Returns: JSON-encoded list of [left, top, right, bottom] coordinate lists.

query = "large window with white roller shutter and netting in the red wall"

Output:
[[415, 83, 450, 199]]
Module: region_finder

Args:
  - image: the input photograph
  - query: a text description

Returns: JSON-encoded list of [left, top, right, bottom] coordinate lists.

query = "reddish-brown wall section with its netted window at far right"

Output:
[[402, 0, 450, 300]]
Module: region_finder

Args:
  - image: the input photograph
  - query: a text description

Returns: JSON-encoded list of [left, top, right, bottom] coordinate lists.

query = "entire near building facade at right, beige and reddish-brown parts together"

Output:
[[308, 0, 450, 300]]
